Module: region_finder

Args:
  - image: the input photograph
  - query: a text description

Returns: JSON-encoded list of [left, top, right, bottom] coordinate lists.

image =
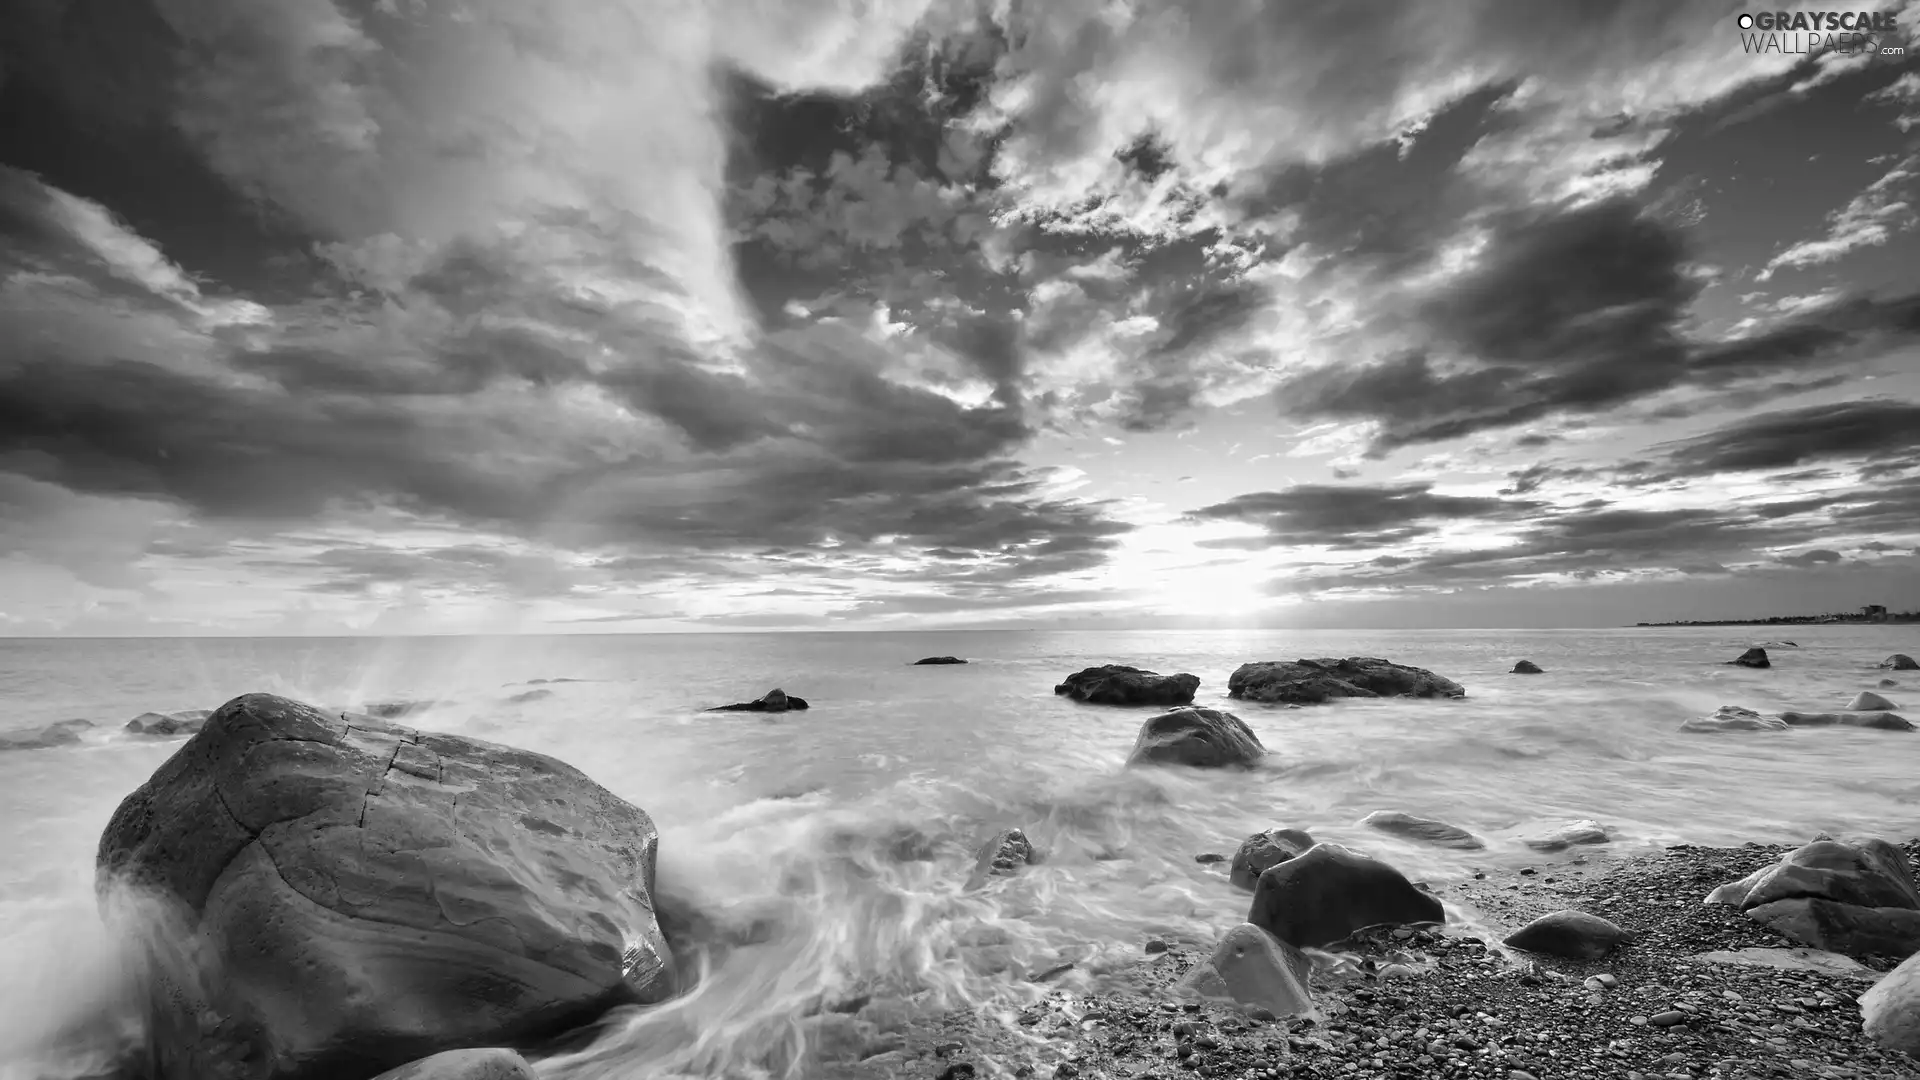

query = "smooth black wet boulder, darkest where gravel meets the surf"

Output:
[[1246, 844, 1446, 949]]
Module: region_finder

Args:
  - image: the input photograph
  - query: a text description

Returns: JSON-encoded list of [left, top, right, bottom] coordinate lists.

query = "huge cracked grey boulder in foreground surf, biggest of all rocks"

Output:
[[98, 694, 672, 1080]]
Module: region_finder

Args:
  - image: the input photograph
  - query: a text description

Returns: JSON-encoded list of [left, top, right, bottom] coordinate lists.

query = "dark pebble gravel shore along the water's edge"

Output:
[[848, 840, 1920, 1080]]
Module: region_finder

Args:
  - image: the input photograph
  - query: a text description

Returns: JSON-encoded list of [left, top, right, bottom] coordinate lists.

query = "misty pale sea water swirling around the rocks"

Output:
[[0, 626, 1920, 1080]]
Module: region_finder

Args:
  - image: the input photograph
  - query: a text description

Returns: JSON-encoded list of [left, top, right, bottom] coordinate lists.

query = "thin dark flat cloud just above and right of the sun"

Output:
[[1188, 484, 1542, 548]]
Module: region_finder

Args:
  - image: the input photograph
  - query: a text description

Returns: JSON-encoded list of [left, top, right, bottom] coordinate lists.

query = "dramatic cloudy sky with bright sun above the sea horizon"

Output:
[[0, 0, 1920, 636]]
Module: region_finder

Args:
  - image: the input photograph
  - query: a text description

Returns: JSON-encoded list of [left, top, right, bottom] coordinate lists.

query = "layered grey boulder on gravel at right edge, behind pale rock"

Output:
[[1707, 840, 1920, 957]]
